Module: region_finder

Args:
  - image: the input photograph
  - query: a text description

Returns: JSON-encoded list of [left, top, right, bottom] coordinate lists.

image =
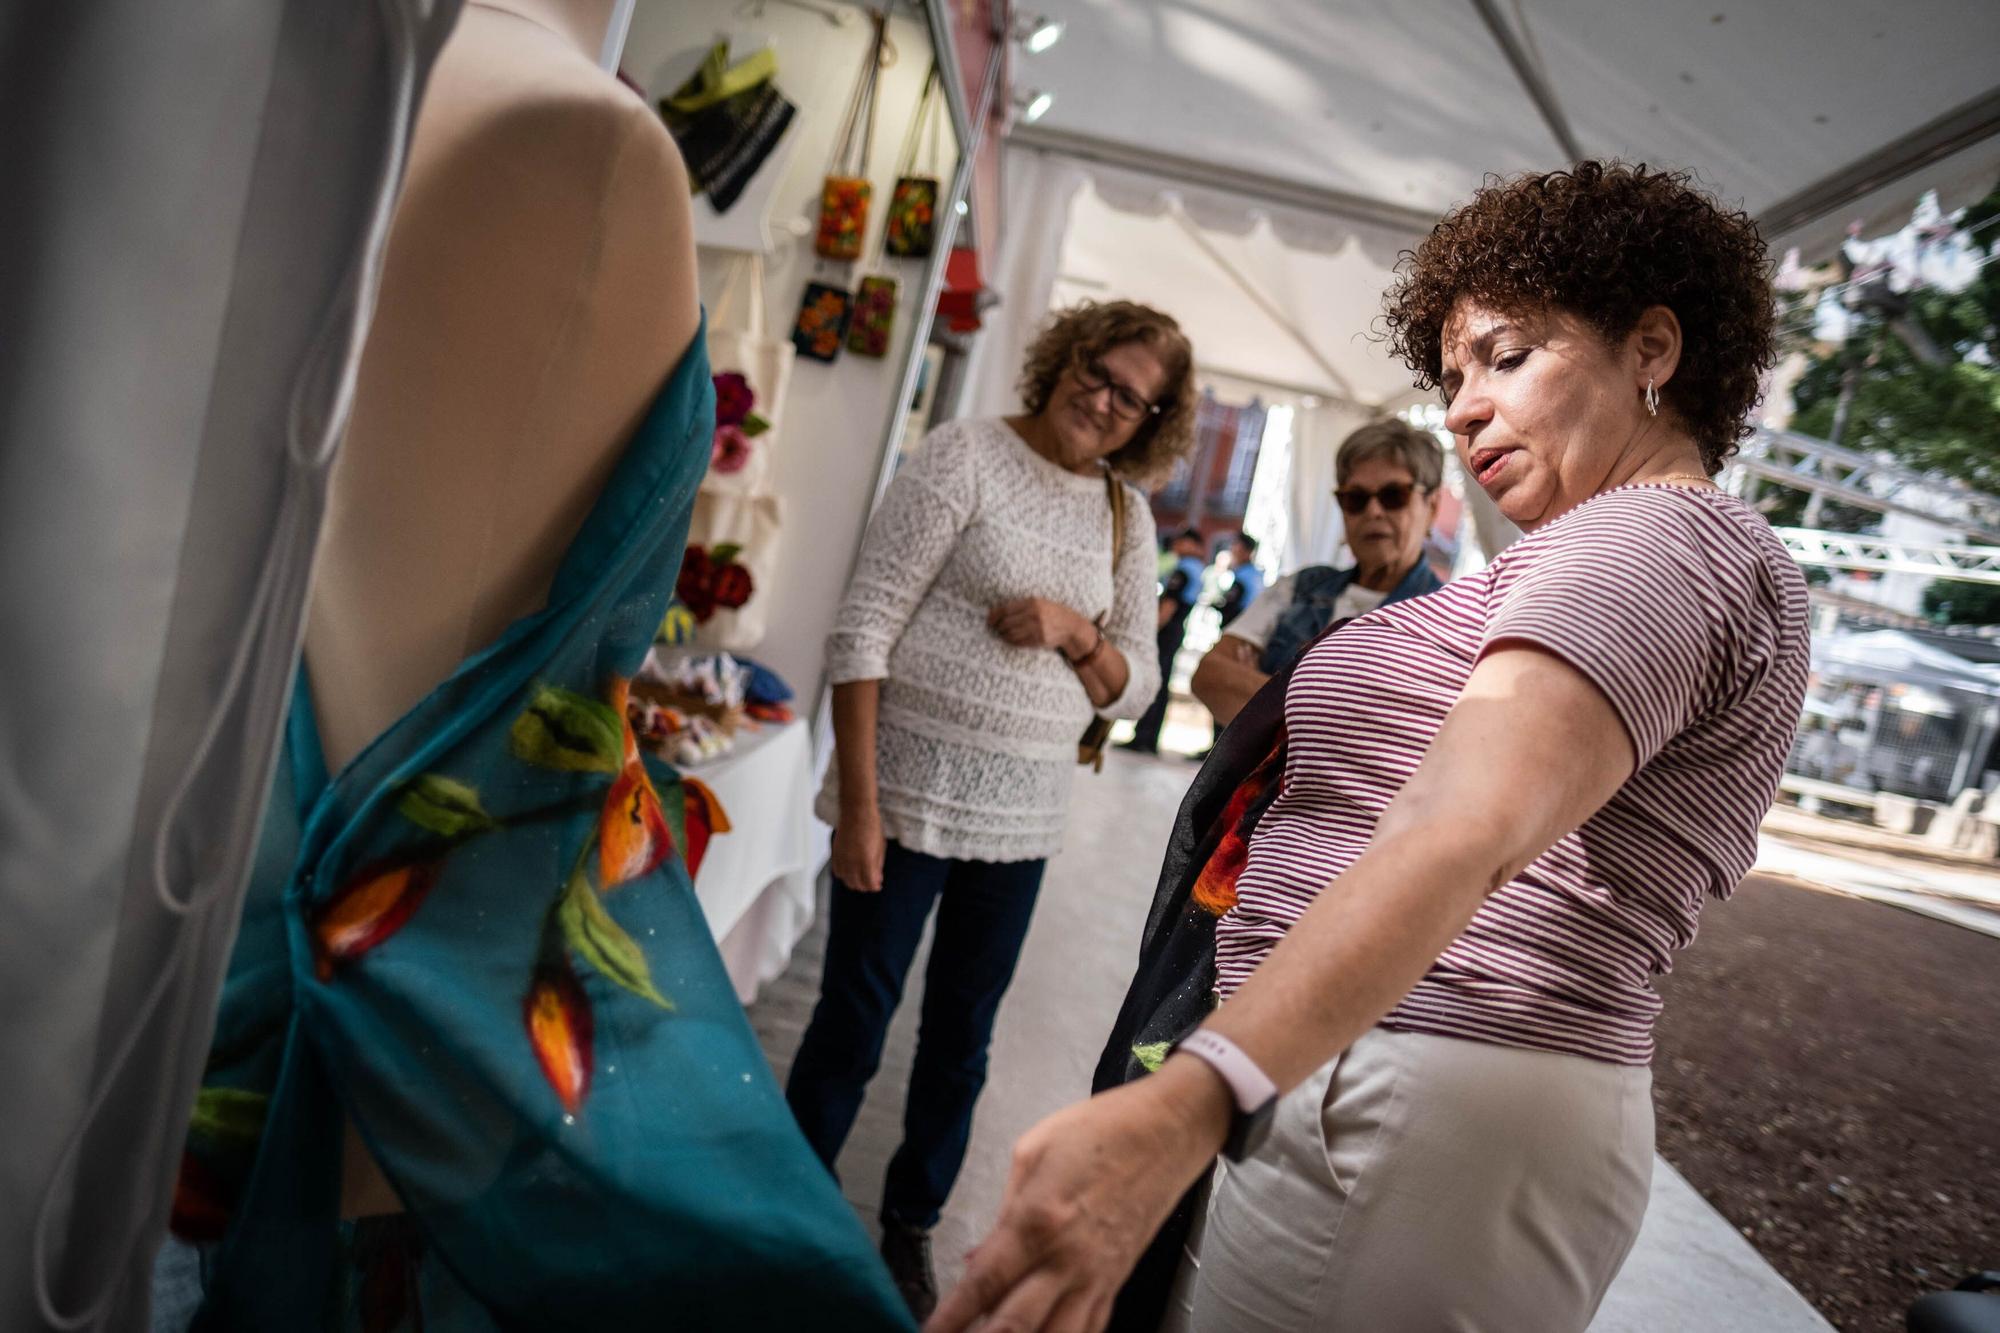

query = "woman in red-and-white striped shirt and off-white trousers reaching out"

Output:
[[932, 162, 1806, 1333]]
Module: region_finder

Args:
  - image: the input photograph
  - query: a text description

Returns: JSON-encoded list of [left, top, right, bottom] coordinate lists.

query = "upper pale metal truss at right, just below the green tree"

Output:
[[1722, 430, 2000, 544]]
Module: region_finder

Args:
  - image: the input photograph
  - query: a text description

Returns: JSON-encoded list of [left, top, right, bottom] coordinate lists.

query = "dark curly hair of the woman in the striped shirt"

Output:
[[1382, 162, 1776, 472]]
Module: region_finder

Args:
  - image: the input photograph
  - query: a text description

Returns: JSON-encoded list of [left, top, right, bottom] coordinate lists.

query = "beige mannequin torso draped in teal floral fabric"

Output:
[[306, 0, 700, 1217]]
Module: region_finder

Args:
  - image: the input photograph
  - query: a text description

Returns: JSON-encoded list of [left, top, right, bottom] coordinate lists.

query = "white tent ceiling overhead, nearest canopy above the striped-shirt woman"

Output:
[[1016, 0, 2000, 250]]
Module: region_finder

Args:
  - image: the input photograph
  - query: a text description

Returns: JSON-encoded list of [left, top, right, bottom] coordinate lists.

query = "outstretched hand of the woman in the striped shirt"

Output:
[[924, 1055, 1230, 1333]]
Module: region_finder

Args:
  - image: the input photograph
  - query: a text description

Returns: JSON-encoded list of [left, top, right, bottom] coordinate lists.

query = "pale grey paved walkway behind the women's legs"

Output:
[[750, 748, 1828, 1333]]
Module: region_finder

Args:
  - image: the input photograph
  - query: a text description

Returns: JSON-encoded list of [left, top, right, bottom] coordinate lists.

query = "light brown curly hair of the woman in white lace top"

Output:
[[1020, 300, 1196, 482]]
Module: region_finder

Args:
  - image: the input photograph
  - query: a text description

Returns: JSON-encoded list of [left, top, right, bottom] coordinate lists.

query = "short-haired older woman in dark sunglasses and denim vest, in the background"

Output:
[[1190, 420, 1444, 729]]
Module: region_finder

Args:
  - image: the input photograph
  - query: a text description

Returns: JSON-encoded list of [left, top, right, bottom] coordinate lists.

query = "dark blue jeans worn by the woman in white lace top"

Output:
[[784, 843, 1048, 1227]]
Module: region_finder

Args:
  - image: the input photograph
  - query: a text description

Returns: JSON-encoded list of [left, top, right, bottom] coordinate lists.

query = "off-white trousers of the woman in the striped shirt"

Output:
[[1162, 1029, 1652, 1333]]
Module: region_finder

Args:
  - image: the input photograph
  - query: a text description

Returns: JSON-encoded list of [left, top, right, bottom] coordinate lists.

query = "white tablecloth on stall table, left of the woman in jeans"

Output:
[[686, 721, 832, 1005]]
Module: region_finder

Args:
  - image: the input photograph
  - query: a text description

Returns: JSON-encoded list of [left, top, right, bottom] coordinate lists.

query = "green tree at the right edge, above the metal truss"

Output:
[[1792, 186, 2000, 492]]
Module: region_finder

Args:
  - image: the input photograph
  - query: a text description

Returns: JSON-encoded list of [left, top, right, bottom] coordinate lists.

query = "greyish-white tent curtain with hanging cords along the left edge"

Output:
[[0, 0, 458, 1333]]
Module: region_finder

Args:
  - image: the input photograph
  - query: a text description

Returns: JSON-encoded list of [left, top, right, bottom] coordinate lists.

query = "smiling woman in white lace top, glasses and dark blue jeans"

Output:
[[786, 302, 1194, 1317]]
